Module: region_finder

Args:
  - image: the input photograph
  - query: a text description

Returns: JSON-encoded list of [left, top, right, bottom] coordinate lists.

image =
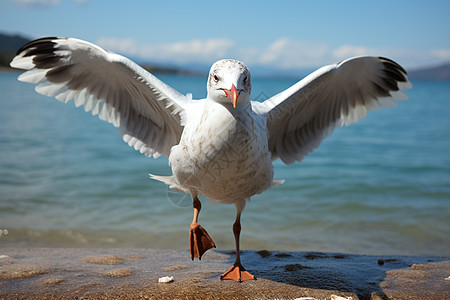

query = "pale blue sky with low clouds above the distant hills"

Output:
[[0, 0, 450, 70]]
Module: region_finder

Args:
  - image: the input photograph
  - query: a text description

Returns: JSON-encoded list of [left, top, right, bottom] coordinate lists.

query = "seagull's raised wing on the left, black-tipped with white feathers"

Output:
[[11, 38, 191, 157]]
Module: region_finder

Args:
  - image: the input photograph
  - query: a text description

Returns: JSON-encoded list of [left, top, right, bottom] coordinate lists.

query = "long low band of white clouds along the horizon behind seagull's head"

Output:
[[97, 37, 450, 70]]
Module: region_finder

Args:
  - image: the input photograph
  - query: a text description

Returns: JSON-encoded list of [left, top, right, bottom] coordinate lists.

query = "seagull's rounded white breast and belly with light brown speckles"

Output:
[[169, 101, 273, 203]]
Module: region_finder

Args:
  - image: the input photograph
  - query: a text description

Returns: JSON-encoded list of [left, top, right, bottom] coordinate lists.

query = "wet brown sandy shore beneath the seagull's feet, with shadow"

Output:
[[0, 248, 450, 299]]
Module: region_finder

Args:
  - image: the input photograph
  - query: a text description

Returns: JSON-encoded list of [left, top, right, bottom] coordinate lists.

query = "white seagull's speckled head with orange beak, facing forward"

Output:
[[208, 59, 252, 108]]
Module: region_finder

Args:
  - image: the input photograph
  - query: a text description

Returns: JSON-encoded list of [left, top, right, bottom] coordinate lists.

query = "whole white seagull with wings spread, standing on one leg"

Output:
[[11, 37, 412, 282]]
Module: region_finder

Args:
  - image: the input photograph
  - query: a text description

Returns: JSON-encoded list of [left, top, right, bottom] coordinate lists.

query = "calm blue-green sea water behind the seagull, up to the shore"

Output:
[[0, 73, 450, 256]]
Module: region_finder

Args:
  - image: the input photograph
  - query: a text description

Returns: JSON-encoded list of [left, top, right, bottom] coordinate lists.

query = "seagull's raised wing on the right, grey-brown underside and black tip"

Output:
[[254, 57, 412, 164]]
